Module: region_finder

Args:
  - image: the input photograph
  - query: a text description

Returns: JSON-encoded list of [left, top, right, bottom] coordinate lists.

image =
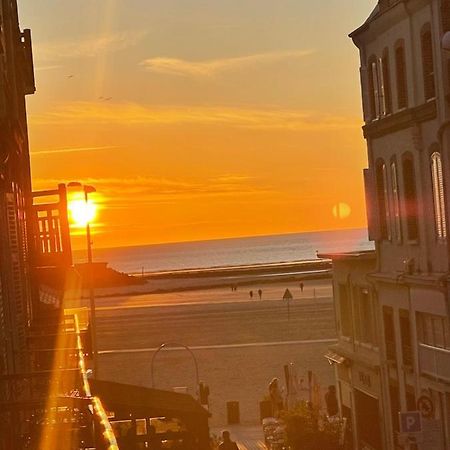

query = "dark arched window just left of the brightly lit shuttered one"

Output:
[[402, 153, 419, 241]]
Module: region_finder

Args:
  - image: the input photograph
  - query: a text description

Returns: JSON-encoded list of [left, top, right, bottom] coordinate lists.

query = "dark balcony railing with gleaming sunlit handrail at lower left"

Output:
[[0, 315, 119, 450]]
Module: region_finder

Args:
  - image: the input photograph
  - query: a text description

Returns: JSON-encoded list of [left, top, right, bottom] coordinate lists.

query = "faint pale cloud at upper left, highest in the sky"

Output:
[[35, 31, 147, 62]]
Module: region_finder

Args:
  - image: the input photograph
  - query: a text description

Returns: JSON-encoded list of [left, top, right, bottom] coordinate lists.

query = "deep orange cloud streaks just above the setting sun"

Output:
[[33, 174, 272, 208]]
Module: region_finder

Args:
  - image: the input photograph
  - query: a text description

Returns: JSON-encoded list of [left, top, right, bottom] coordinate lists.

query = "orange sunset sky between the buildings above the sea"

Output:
[[20, 0, 376, 247]]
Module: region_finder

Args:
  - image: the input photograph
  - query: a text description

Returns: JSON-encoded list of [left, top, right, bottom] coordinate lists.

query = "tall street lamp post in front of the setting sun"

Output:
[[67, 181, 98, 378]]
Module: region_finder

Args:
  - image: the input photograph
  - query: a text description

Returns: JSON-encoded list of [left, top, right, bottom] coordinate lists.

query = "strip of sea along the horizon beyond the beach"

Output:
[[74, 229, 373, 274]]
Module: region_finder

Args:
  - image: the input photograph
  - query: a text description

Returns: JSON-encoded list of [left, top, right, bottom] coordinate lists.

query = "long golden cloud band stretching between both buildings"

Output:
[[30, 102, 359, 130]]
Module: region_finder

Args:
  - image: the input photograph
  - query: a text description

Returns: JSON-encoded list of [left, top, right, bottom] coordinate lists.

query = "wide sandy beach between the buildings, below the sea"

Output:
[[73, 266, 335, 427]]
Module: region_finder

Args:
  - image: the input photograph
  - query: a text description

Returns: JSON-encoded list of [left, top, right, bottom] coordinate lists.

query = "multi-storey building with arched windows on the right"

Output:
[[327, 0, 450, 450]]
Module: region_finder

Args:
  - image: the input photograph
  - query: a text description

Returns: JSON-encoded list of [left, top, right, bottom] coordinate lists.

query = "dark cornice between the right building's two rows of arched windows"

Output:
[[362, 99, 437, 139]]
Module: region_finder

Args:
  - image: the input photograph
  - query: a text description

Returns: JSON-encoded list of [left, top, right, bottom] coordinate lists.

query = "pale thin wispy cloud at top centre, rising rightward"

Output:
[[141, 50, 314, 77]]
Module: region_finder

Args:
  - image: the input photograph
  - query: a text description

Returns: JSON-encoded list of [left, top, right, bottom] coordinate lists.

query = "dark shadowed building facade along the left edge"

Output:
[[0, 0, 35, 380]]
